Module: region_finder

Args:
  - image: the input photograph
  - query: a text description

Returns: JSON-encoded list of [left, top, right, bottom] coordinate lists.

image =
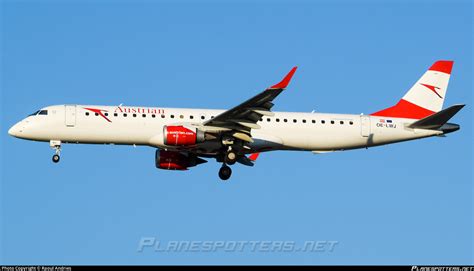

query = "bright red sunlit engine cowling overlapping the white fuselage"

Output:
[[163, 126, 204, 146]]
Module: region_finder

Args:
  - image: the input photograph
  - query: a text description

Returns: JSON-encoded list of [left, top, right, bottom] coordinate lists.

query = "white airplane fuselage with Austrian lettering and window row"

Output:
[[9, 105, 443, 154]]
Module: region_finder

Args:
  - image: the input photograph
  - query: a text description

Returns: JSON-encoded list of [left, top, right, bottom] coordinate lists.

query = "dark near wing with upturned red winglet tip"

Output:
[[203, 67, 297, 142]]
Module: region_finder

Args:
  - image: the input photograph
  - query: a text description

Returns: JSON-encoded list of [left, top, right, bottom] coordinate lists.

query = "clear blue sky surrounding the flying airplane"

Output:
[[0, 1, 474, 264]]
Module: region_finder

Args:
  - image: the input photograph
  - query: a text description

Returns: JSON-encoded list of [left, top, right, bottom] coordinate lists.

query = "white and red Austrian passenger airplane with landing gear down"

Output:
[[8, 60, 464, 180]]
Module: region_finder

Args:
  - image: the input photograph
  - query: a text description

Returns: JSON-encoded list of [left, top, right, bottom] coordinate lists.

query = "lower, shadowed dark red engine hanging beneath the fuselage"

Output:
[[155, 150, 207, 170]]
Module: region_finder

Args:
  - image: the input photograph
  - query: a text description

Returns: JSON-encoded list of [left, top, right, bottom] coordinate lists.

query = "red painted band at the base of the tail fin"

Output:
[[370, 99, 435, 119]]
